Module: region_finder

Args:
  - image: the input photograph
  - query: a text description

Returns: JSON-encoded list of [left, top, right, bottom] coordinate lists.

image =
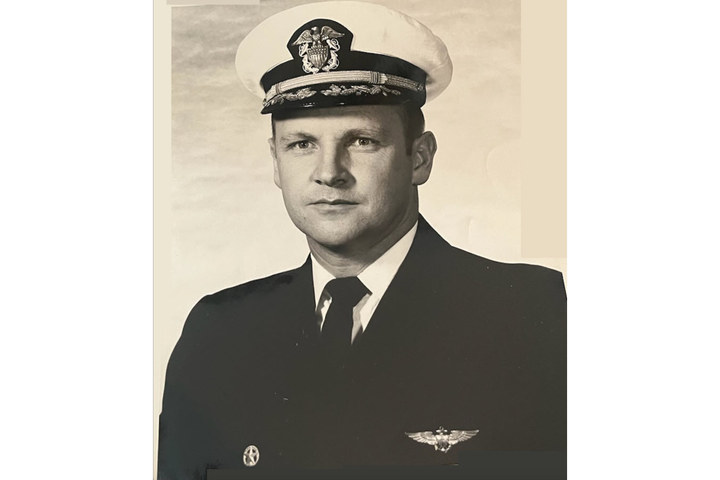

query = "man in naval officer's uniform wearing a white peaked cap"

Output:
[[159, 2, 567, 479]]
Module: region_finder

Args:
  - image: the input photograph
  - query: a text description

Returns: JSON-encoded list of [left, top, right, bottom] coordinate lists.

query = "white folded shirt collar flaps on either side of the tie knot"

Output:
[[310, 222, 418, 307]]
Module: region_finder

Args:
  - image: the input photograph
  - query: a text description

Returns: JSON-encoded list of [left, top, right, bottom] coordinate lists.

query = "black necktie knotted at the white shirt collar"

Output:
[[320, 277, 368, 361]]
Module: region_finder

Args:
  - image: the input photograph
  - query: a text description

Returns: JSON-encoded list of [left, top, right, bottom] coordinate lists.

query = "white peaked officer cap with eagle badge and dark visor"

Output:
[[235, 2, 452, 113]]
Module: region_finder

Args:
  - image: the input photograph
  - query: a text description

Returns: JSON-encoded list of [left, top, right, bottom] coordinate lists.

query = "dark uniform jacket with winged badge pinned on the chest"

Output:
[[159, 217, 567, 479]]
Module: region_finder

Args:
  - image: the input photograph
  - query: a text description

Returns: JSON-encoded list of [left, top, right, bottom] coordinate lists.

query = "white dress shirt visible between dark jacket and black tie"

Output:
[[310, 222, 417, 341]]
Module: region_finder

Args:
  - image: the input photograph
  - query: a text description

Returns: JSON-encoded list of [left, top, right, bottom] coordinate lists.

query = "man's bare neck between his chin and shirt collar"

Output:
[[308, 212, 418, 278]]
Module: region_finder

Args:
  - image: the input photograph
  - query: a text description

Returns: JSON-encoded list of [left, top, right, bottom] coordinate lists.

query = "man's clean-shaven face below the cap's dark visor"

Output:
[[270, 105, 429, 251]]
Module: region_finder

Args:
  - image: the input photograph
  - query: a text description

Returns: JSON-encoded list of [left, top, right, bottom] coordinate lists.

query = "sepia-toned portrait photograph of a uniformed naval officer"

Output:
[[151, 0, 569, 480]]
